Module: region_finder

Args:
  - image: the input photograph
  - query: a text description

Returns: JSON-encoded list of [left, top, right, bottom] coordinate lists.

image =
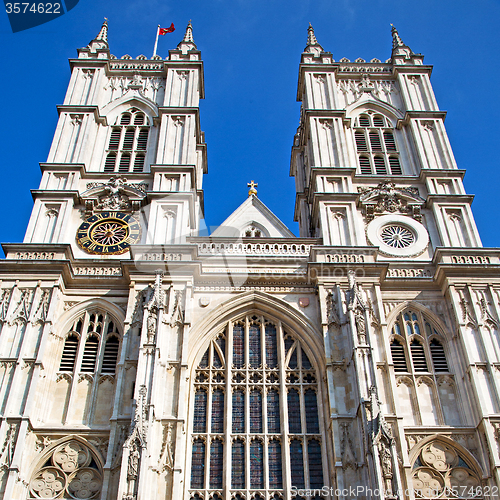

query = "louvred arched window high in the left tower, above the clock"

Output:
[[104, 108, 149, 173]]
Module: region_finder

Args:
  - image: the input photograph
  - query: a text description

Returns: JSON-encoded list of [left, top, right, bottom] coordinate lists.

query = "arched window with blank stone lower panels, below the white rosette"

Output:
[[390, 309, 460, 425]]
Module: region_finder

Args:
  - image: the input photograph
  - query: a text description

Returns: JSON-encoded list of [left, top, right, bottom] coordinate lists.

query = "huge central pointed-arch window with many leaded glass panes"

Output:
[[189, 314, 328, 500]]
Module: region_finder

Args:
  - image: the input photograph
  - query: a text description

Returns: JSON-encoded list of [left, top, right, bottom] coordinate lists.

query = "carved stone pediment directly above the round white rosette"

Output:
[[358, 181, 425, 222]]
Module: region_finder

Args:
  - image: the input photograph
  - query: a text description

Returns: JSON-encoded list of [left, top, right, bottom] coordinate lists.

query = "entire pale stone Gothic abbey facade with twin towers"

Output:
[[0, 19, 500, 500]]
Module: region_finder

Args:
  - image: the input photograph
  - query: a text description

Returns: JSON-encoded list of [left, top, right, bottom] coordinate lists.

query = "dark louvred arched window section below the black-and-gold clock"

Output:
[[59, 310, 120, 374]]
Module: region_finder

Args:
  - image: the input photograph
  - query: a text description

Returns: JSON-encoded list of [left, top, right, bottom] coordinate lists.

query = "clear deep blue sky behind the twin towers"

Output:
[[0, 0, 500, 246]]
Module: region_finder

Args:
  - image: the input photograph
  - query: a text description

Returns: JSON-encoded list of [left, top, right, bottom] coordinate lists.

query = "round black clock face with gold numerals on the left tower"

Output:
[[76, 212, 141, 255]]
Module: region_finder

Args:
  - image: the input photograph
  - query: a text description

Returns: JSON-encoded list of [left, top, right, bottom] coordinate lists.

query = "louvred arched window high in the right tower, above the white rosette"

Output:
[[354, 111, 403, 175]]
